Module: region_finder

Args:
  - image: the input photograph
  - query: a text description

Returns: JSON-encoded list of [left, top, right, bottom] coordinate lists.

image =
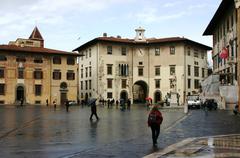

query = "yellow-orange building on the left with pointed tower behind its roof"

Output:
[[0, 27, 79, 105]]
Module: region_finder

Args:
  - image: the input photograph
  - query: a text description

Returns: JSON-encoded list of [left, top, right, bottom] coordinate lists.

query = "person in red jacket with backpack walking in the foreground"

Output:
[[148, 105, 163, 146]]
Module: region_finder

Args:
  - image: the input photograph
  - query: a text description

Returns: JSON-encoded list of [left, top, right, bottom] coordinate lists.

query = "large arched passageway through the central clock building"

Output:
[[133, 81, 148, 104]]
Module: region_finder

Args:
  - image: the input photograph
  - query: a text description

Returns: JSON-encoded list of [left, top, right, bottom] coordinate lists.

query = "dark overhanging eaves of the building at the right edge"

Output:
[[203, 0, 234, 35]]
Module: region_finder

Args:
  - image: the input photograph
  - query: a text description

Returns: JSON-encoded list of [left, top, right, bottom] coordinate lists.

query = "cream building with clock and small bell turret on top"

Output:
[[74, 28, 211, 104]]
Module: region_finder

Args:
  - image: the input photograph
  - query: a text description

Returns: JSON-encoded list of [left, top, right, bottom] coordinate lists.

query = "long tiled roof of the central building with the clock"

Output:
[[73, 37, 212, 51]]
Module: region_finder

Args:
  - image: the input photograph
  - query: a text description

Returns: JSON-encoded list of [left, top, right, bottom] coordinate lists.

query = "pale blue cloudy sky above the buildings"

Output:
[[0, 0, 221, 64]]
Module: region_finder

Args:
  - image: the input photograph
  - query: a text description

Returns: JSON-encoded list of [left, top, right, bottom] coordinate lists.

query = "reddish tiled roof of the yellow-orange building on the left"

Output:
[[0, 45, 82, 56]]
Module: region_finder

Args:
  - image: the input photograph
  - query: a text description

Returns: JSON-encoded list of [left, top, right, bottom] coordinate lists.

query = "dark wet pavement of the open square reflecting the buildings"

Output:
[[0, 106, 240, 158]]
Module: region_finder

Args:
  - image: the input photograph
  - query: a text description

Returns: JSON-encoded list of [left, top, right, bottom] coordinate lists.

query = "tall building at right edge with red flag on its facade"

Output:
[[203, 0, 239, 85]]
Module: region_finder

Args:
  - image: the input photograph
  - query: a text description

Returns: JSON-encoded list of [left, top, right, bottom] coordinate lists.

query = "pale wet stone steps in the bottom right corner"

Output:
[[144, 134, 240, 158]]
